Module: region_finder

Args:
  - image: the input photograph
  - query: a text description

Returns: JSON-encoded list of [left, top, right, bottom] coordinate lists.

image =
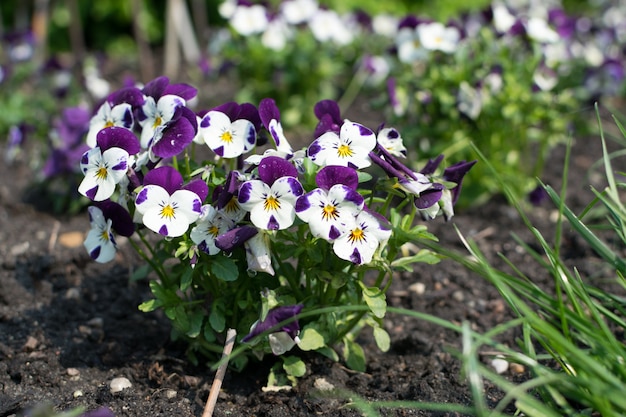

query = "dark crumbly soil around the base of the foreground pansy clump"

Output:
[[0, 103, 620, 417]]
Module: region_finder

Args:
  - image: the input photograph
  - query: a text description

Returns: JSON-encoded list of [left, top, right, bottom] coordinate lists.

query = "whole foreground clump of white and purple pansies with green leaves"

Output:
[[78, 77, 473, 376]]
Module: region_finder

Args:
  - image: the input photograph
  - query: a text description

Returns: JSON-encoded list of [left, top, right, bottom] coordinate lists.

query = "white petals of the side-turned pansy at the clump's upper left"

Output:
[[137, 94, 185, 149]]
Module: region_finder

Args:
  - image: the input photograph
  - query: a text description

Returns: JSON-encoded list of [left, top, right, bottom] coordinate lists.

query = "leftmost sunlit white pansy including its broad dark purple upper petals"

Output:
[[78, 127, 140, 201]]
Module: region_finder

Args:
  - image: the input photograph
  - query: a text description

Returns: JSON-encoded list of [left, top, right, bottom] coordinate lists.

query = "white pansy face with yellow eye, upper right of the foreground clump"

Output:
[[307, 120, 376, 169]]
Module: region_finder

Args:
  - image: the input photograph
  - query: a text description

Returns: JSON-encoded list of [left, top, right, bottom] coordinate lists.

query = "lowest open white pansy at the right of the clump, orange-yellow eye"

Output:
[[333, 209, 391, 265]]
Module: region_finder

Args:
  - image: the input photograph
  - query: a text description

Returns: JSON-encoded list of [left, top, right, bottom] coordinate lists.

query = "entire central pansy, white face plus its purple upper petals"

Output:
[[238, 156, 304, 230]]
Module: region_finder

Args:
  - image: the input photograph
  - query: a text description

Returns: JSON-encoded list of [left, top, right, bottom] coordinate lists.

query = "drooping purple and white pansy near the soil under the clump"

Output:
[[241, 304, 304, 355]]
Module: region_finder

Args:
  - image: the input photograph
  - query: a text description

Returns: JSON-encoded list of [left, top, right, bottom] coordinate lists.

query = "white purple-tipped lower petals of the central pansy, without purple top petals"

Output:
[[239, 176, 304, 230]]
